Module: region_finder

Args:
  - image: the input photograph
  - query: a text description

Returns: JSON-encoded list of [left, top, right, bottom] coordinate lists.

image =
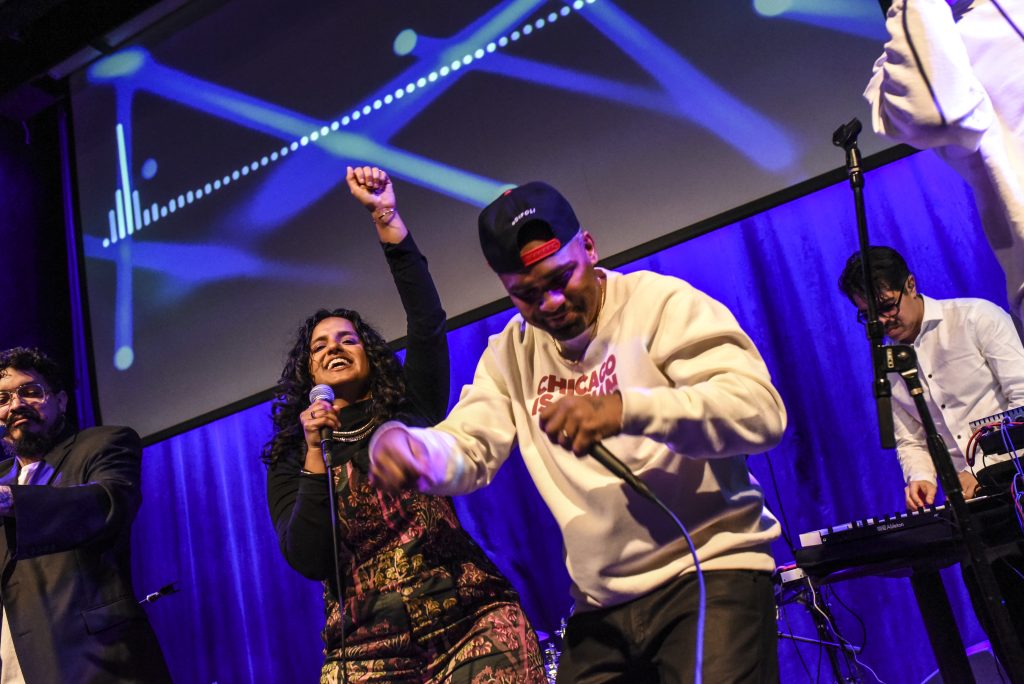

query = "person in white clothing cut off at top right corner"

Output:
[[864, 0, 1024, 318]]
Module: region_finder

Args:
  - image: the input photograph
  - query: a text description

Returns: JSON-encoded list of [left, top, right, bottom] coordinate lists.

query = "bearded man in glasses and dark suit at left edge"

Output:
[[0, 347, 170, 684]]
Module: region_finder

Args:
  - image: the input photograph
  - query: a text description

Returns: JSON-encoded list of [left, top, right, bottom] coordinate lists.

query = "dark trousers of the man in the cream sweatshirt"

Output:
[[558, 570, 778, 684]]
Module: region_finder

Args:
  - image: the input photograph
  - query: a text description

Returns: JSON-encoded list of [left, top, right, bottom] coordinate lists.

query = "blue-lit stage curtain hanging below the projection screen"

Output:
[[134, 148, 1006, 683]]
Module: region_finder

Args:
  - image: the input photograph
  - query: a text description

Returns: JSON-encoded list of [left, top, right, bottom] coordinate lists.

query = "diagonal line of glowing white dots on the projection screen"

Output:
[[102, 0, 596, 247]]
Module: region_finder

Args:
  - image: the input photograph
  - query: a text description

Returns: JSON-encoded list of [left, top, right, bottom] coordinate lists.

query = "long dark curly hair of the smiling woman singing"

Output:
[[262, 309, 406, 466]]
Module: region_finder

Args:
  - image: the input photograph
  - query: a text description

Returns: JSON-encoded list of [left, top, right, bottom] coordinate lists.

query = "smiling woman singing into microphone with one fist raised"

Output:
[[263, 167, 546, 684]]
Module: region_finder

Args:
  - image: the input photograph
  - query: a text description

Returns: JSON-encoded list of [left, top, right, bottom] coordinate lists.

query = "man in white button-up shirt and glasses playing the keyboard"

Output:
[[839, 247, 1024, 663]]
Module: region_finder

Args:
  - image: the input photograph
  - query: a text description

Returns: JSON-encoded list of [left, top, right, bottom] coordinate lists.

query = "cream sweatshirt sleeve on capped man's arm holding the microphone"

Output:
[[620, 279, 786, 458]]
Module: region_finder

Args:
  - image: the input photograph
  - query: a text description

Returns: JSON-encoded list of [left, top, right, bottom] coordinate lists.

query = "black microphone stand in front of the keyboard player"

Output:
[[833, 119, 1024, 684]]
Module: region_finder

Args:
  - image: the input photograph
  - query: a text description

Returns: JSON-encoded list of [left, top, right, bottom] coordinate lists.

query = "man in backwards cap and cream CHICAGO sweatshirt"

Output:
[[371, 182, 785, 682]]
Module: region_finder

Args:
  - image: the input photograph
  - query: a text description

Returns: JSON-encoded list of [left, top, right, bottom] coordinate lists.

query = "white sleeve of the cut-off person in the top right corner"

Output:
[[864, 0, 994, 152]]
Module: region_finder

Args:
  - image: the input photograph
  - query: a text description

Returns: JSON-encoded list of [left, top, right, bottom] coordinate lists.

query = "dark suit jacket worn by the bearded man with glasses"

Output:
[[0, 427, 170, 684]]
